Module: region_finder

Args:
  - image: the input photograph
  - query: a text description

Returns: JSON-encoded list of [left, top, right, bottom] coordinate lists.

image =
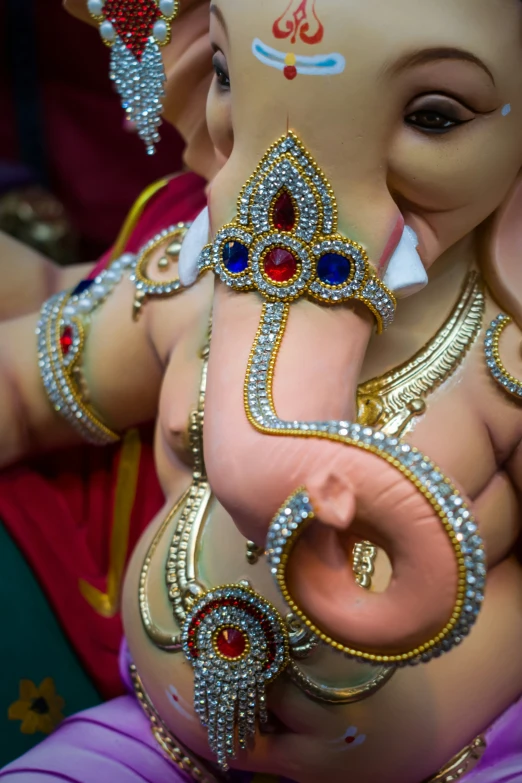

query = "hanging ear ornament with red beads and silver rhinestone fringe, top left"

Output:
[[87, 0, 180, 155]]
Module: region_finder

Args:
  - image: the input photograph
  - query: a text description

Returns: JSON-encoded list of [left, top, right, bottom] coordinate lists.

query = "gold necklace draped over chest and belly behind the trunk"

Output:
[[140, 272, 484, 704]]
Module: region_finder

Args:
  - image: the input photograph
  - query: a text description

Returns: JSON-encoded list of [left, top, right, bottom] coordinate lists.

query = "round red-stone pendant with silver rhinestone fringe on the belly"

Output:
[[183, 585, 288, 770]]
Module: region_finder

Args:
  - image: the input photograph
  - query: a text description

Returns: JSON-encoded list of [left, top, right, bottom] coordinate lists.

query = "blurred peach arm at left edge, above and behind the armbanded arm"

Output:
[[0, 231, 92, 321]]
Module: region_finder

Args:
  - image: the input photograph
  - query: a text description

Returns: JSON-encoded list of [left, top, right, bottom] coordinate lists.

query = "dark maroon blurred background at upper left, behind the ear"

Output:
[[0, 0, 186, 264]]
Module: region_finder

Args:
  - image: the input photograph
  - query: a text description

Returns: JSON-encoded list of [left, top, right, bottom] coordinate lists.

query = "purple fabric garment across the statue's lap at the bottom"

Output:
[[0, 644, 522, 783]]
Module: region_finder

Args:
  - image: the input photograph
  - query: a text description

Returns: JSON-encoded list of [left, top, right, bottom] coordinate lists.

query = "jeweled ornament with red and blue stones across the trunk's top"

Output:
[[199, 131, 396, 332]]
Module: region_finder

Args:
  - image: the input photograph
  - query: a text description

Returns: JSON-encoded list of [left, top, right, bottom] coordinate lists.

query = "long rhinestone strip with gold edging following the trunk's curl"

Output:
[[244, 302, 487, 666]]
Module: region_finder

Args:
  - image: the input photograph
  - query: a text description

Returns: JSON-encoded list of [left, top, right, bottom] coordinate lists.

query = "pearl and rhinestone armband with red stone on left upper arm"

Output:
[[36, 223, 188, 446]]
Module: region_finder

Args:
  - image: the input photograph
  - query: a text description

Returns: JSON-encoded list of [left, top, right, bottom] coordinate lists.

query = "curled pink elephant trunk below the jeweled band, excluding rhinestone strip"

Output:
[[205, 282, 464, 656]]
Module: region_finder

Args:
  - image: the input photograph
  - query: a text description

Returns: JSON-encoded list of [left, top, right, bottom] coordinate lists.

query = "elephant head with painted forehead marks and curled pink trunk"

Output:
[[66, 0, 522, 658]]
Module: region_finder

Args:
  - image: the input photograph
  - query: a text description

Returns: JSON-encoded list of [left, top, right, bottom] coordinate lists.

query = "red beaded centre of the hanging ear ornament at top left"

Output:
[[103, 0, 161, 60]]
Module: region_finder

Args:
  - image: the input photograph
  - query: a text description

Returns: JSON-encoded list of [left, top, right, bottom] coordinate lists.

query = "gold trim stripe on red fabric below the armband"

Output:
[[78, 430, 141, 618]]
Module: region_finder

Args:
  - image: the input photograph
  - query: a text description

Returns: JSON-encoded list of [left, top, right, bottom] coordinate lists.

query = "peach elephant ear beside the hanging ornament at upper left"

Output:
[[163, 0, 218, 180]]
